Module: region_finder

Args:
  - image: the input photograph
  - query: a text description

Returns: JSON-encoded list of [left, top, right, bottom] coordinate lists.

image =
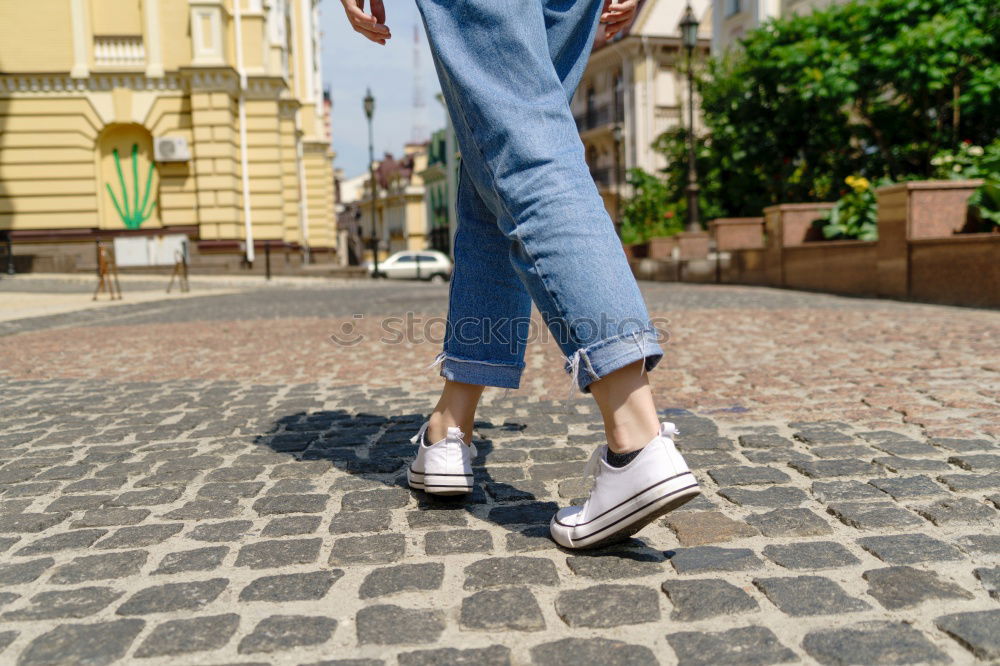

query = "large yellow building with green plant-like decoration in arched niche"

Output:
[[0, 0, 336, 271]]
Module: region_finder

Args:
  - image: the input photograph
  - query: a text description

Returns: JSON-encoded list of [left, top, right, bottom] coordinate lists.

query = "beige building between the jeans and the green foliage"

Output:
[[572, 0, 712, 222]]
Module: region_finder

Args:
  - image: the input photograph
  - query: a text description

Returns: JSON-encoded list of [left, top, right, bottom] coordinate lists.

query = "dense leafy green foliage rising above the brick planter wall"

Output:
[[672, 0, 1000, 217]]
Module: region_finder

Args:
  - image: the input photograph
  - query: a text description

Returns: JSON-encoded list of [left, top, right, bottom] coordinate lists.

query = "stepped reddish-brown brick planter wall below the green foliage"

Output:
[[632, 180, 1000, 307]]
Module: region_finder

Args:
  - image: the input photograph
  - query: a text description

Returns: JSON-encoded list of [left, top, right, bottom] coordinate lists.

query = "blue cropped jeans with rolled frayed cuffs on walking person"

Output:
[[416, 0, 663, 393]]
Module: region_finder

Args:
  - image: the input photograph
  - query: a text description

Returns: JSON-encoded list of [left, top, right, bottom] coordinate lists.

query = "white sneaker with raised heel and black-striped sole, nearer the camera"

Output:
[[549, 421, 701, 548]]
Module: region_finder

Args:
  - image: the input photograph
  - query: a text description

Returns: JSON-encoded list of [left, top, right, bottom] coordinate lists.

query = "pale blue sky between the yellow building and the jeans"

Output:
[[320, 0, 445, 178]]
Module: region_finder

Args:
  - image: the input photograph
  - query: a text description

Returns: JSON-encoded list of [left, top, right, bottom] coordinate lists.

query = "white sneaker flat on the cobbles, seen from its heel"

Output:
[[406, 421, 476, 495]]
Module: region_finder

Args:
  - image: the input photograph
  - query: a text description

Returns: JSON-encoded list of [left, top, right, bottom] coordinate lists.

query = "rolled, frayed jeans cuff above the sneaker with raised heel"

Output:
[[564, 327, 664, 400]]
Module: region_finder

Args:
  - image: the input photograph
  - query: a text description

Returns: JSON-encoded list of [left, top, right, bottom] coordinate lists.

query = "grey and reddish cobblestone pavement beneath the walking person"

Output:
[[0, 283, 1000, 666]]
